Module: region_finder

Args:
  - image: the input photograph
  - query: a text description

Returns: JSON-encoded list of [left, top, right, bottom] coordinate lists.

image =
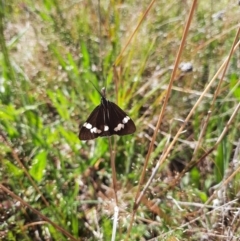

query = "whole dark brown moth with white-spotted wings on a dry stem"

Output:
[[79, 88, 136, 140]]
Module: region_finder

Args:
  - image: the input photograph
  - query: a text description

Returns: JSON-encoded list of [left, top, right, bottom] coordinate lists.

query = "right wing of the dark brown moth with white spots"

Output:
[[107, 101, 136, 136]]
